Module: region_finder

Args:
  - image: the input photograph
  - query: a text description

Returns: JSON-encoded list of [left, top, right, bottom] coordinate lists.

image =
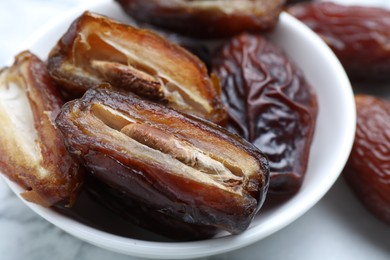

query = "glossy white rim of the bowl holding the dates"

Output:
[[2, 0, 356, 259]]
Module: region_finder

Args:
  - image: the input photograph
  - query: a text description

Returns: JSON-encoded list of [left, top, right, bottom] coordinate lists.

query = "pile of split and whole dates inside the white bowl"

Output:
[[0, 0, 318, 240]]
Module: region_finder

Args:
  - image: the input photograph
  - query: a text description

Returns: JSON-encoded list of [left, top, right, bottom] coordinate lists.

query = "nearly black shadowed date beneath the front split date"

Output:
[[80, 178, 218, 241]]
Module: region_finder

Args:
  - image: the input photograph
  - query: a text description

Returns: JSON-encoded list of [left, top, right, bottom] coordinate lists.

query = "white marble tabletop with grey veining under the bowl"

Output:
[[0, 0, 390, 260]]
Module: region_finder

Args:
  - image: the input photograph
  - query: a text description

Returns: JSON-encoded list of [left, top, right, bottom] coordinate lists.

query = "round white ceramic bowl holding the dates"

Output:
[[3, 2, 355, 259]]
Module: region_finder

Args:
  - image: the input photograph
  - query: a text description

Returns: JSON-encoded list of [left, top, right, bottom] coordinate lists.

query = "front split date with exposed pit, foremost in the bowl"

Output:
[[56, 87, 269, 233]]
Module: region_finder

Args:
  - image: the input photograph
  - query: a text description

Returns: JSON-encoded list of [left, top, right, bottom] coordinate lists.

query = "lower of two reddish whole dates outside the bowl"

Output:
[[343, 94, 390, 224]]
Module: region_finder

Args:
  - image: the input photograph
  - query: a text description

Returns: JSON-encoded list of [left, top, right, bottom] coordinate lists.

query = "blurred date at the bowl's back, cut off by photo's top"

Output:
[[116, 0, 286, 38]]
